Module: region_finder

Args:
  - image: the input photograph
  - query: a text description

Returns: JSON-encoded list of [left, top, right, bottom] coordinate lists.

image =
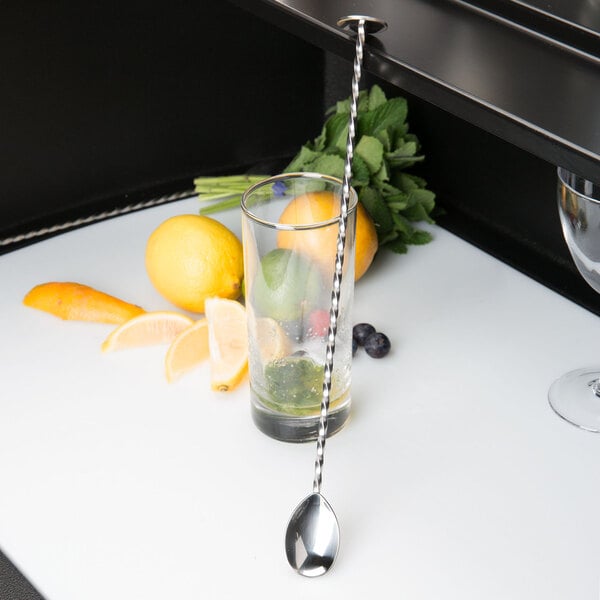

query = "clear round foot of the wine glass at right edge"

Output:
[[548, 367, 600, 433]]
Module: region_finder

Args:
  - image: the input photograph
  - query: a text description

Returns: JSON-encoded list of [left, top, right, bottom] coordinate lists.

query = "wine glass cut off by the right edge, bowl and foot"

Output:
[[548, 167, 600, 432]]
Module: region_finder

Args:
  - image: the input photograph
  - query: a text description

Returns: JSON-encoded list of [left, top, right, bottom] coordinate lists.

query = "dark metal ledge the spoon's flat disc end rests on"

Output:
[[239, 0, 600, 180]]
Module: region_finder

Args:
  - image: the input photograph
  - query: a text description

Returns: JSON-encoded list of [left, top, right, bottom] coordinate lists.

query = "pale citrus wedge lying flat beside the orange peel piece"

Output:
[[102, 311, 194, 352]]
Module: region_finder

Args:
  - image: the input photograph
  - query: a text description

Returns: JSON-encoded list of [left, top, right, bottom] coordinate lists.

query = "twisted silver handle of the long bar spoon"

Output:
[[313, 19, 365, 493]]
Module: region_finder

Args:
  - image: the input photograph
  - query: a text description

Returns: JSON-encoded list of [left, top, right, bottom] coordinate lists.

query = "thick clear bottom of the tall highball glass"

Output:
[[251, 392, 351, 443]]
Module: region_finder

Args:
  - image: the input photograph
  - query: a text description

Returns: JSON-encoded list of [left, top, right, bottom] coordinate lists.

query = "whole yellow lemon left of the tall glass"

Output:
[[146, 215, 244, 313]]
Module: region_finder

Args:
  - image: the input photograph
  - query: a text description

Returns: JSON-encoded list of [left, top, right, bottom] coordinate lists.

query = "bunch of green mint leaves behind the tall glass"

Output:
[[284, 85, 435, 253]]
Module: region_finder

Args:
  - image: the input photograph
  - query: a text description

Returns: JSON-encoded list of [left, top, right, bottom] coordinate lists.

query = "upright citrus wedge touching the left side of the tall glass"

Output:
[[204, 298, 248, 392]]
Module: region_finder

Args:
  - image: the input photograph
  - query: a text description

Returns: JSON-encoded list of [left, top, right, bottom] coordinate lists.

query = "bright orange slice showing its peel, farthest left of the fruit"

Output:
[[23, 281, 145, 325]]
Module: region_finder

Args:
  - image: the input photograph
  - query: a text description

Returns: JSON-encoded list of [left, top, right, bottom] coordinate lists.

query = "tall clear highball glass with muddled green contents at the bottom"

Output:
[[242, 173, 357, 442]]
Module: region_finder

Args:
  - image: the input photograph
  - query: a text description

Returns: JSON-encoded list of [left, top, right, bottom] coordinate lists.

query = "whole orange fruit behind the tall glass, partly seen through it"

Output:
[[277, 192, 378, 281]]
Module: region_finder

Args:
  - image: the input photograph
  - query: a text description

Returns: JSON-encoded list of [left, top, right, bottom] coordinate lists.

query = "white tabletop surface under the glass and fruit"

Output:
[[0, 200, 600, 600]]
